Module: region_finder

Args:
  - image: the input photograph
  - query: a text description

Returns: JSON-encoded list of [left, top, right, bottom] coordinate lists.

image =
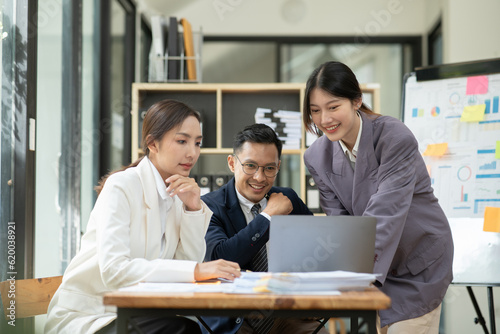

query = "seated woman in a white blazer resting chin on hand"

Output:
[[45, 100, 239, 334]]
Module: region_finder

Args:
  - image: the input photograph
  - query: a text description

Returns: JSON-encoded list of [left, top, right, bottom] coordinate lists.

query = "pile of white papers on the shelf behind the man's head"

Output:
[[255, 108, 302, 149]]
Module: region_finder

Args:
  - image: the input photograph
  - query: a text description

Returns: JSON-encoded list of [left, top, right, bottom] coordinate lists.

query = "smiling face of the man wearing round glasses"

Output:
[[227, 142, 280, 203]]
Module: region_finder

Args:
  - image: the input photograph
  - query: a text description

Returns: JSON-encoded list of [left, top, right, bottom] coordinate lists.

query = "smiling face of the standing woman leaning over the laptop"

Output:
[[309, 88, 361, 149]]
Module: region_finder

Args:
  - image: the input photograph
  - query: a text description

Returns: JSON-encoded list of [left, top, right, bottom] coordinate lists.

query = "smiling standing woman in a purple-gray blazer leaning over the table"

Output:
[[303, 61, 453, 334]]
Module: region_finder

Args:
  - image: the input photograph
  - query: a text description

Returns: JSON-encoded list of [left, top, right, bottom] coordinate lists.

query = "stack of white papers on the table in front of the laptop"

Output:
[[229, 271, 377, 294]]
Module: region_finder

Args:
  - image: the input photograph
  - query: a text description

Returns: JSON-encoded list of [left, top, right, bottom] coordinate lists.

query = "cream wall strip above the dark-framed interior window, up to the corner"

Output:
[[139, 0, 425, 38]]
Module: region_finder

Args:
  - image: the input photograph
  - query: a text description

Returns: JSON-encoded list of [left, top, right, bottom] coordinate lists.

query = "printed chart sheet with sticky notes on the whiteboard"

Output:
[[404, 74, 500, 217]]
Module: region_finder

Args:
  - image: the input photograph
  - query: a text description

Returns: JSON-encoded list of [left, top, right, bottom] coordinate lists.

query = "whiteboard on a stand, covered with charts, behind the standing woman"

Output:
[[402, 68, 500, 285]]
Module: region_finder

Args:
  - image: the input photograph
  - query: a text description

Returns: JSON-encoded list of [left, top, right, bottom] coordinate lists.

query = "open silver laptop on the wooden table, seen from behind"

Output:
[[268, 215, 377, 273]]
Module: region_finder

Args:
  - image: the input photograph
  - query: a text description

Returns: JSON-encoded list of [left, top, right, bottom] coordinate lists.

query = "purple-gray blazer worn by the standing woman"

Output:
[[304, 112, 453, 327]]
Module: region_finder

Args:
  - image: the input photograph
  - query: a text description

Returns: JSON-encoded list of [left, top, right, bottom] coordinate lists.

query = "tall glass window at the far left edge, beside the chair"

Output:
[[0, 0, 37, 333]]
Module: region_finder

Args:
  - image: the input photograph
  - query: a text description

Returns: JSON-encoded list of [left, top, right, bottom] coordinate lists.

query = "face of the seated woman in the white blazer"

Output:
[[148, 116, 202, 180]]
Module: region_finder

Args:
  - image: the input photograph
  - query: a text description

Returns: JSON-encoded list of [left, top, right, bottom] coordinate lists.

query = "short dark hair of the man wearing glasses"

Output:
[[233, 123, 283, 158]]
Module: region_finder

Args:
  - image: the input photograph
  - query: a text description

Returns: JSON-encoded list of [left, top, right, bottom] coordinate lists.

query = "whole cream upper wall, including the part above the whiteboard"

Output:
[[138, 0, 500, 63]]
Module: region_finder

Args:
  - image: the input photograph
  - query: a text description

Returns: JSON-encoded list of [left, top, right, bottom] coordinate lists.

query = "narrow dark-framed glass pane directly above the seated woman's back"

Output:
[[99, 0, 136, 176]]
